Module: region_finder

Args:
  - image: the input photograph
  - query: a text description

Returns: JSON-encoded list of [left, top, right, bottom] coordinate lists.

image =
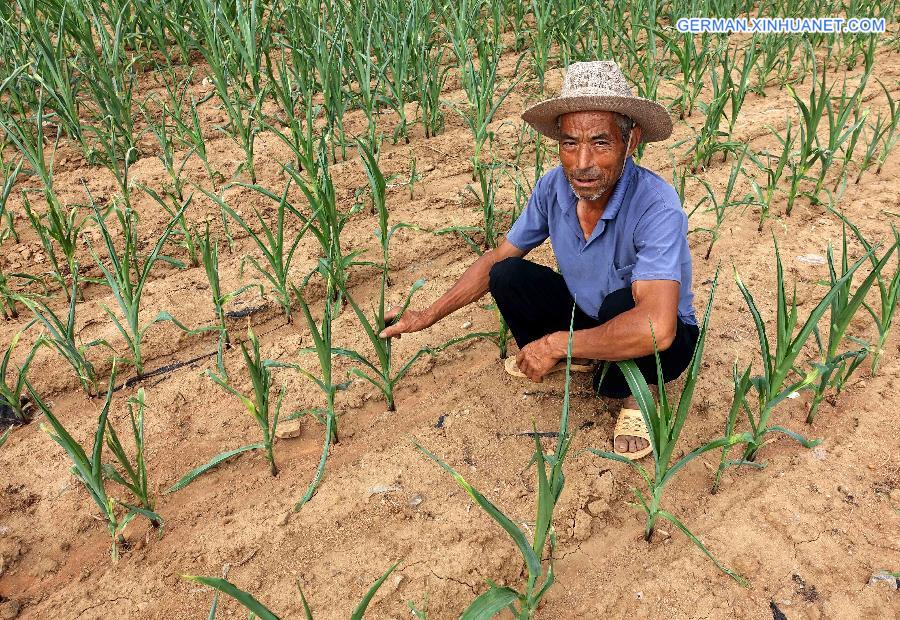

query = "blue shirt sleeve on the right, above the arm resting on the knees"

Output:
[[631, 206, 688, 284]]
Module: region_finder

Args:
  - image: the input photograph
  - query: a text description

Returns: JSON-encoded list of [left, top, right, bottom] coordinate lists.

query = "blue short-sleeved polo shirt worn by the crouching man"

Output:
[[506, 157, 697, 325]]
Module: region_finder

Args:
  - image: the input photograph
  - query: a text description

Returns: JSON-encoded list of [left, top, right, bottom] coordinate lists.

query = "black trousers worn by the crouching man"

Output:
[[489, 257, 700, 398]]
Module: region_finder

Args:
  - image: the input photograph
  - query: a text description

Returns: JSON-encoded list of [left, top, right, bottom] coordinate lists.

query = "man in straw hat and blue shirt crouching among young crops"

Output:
[[381, 61, 699, 459]]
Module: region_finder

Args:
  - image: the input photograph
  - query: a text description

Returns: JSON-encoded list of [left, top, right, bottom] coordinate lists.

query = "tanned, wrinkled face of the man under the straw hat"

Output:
[[559, 112, 640, 200]]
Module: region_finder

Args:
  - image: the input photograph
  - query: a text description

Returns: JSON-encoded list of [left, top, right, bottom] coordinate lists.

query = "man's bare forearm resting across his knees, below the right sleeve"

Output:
[[547, 308, 674, 362]]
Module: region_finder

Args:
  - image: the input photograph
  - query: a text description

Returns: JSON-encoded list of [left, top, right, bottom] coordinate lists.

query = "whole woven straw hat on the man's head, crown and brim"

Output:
[[522, 60, 672, 142]]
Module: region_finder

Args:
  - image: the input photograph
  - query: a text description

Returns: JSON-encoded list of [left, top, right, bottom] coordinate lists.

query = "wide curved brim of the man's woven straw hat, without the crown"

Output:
[[522, 95, 672, 142]]
